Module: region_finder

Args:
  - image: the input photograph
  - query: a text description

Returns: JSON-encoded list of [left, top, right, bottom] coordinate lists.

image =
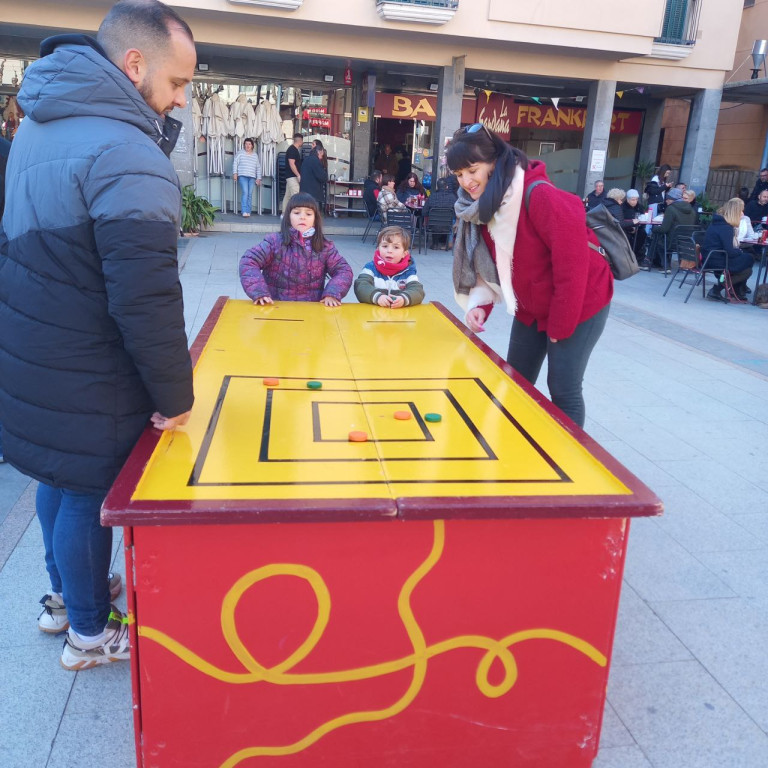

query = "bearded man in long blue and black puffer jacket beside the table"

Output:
[[0, 0, 196, 669]]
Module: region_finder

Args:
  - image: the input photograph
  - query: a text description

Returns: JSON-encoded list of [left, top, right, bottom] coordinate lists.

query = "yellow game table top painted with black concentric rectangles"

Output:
[[117, 300, 657, 514]]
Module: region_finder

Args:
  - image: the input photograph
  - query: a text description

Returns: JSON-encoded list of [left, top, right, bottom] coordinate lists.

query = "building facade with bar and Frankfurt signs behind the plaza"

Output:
[[0, 0, 742, 207]]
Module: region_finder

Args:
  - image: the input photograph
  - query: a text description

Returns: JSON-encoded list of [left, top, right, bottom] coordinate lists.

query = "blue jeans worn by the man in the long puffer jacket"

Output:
[[36, 483, 112, 635]]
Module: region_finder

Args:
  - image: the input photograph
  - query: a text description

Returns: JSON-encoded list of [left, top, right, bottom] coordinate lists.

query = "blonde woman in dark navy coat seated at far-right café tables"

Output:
[[702, 197, 754, 302]]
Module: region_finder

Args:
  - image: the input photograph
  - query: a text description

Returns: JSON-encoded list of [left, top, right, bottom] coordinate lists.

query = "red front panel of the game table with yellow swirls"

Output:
[[129, 519, 628, 768]]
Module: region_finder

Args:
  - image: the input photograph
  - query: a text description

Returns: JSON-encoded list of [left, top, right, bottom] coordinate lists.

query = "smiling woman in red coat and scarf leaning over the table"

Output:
[[447, 123, 613, 427]]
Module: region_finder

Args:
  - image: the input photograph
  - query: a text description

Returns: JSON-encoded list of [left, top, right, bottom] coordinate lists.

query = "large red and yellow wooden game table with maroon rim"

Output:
[[102, 298, 661, 768]]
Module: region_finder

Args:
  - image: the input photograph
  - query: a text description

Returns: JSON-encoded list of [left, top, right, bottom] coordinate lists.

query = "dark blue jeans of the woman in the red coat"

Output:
[[507, 306, 608, 427]]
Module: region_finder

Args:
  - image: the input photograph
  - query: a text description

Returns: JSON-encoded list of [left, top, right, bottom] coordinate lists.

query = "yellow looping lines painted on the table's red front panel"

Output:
[[138, 520, 607, 768]]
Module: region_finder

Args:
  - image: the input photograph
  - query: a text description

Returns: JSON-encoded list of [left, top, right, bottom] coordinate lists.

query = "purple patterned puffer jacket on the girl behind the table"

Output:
[[240, 229, 354, 301]]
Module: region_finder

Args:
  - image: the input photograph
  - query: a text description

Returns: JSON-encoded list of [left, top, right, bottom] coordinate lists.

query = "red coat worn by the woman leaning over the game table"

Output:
[[481, 160, 613, 339]]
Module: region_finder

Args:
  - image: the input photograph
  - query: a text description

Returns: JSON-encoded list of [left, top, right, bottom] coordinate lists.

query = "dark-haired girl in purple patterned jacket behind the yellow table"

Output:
[[240, 193, 353, 307]]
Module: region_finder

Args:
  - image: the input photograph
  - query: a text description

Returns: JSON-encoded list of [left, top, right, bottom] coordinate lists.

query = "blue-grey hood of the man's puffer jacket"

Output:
[[18, 35, 164, 142]]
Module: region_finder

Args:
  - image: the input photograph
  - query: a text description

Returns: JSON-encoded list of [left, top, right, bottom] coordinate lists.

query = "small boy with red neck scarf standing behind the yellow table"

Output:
[[355, 227, 424, 309]]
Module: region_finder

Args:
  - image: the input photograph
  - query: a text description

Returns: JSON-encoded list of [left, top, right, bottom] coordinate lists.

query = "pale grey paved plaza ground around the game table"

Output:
[[0, 217, 768, 768]]
